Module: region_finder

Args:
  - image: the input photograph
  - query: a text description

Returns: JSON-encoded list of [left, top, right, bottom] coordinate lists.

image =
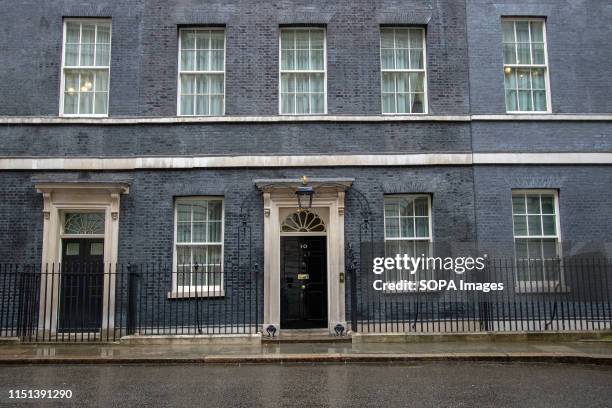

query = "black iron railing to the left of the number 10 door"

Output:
[[0, 263, 261, 342]]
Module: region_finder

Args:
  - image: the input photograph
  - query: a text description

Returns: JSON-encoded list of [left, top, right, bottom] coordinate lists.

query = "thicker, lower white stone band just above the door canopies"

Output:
[[0, 153, 612, 171]]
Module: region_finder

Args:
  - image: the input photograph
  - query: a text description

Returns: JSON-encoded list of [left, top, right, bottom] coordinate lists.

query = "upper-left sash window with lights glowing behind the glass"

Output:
[[60, 19, 111, 116]]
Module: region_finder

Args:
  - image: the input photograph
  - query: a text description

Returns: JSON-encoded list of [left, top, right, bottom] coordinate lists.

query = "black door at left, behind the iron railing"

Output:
[[58, 239, 104, 332]]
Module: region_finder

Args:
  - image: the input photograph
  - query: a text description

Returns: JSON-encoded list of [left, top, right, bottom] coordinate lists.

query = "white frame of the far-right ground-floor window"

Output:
[[510, 189, 568, 293]]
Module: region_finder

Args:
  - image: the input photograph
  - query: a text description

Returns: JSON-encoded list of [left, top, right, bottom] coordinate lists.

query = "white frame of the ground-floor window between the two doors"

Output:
[[168, 196, 225, 298]]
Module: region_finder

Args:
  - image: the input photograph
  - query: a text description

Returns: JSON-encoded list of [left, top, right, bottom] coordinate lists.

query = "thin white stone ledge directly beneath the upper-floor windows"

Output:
[[0, 114, 612, 125]]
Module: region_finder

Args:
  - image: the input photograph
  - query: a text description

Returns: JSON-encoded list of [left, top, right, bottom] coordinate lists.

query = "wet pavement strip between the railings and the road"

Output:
[[0, 341, 612, 365]]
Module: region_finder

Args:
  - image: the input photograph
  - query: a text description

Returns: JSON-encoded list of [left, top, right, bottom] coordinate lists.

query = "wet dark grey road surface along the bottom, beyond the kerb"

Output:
[[0, 362, 612, 407]]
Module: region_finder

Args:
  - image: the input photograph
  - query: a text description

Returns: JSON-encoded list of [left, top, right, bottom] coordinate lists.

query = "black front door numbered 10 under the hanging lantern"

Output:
[[281, 236, 327, 329]]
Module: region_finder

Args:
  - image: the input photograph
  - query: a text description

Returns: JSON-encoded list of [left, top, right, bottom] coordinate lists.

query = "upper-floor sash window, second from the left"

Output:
[[178, 28, 225, 116]]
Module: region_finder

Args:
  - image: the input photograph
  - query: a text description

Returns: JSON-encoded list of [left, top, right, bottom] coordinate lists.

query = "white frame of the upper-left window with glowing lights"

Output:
[[59, 18, 113, 118]]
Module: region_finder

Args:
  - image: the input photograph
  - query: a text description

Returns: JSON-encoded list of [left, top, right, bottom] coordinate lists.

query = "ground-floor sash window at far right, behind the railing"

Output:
[[512, 190, 560, 290]]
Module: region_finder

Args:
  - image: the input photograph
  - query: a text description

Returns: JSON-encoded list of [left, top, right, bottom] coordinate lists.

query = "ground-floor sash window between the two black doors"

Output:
[[173, 197, 223, 296]]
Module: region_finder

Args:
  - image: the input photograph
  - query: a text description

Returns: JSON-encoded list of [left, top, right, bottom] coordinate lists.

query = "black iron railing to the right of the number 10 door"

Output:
[[348, 256, 612, 333]]
